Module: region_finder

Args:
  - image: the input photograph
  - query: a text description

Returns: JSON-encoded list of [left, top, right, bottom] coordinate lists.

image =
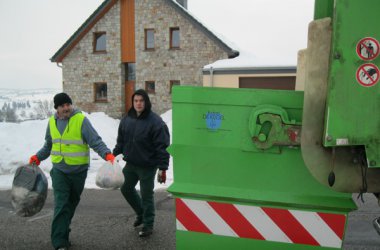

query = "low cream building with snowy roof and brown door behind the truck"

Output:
[[203, 52, 303, 90]]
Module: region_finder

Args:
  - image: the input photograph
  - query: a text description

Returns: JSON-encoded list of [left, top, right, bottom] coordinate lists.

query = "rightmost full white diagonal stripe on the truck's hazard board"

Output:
[[289, 210, 342, 247]]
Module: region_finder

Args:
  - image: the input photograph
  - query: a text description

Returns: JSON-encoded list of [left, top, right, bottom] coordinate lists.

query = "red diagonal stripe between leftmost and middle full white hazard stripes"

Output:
[[208, 202, 264, 240]]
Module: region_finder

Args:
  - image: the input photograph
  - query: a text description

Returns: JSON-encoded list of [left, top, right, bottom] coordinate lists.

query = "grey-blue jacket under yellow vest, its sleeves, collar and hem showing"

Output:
[[37, 109, 111, 173]]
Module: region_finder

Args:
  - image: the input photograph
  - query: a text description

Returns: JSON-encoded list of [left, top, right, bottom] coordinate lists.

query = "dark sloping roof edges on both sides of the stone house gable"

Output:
[[50, 0, 239, 62]]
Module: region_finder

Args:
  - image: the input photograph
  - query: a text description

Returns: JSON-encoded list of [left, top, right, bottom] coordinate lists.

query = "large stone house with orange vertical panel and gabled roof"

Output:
[[50, 0, 239, 118]]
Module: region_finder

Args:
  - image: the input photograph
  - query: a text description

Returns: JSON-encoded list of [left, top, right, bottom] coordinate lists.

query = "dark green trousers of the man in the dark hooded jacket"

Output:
[[120, 164, 157, 228]]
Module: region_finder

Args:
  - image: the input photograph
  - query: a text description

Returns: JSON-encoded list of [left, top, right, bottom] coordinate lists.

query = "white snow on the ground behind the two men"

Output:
[[0, 98, 173, 190]]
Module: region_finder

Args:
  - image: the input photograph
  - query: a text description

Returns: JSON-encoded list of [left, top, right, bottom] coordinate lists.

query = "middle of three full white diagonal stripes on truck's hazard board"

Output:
[[235, 205, 292, 243]]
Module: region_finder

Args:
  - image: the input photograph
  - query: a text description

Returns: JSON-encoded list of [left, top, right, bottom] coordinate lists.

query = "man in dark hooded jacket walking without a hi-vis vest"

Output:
[[113, 89, 170, 237]]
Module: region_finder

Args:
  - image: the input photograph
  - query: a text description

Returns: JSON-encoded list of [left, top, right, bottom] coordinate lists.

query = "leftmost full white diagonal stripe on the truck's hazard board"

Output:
[[183, 199, 237, 237]]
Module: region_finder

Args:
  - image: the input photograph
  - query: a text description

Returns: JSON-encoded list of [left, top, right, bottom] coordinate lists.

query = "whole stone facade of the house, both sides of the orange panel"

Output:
[[62, 0, 228, 118]]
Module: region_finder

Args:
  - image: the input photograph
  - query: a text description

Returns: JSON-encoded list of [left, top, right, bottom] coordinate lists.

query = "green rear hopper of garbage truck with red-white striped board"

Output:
[[169, 86, 356, 249]]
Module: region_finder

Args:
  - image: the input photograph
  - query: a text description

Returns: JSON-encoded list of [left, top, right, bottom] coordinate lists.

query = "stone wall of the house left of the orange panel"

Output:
[[62, 3, 124, 118]]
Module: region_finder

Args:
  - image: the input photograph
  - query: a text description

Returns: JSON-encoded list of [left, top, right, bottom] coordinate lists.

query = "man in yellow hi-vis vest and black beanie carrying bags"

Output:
[[29, 93, 115, 249]]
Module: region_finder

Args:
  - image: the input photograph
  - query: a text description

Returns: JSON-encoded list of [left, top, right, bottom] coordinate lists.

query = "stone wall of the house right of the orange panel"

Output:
[[135, 0, 228, 113]]
